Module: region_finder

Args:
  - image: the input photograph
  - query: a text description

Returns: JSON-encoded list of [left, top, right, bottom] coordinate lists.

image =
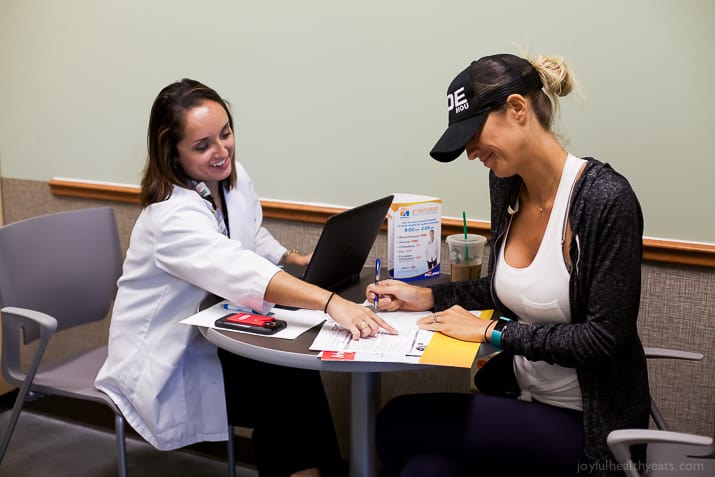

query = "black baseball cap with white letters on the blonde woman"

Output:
[[430, 54, 542, 162]]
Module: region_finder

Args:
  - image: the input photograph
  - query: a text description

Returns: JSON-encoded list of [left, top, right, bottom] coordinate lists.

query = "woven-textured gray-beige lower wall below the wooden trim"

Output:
[[3, 179, 715, 452]]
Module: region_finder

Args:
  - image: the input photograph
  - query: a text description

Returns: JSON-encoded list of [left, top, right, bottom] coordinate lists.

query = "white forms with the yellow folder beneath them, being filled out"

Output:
[[310, 310, 493, 368]]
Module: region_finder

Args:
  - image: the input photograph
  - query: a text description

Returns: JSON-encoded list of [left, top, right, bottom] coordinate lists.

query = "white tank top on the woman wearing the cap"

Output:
[[494, 154, 585, 411]]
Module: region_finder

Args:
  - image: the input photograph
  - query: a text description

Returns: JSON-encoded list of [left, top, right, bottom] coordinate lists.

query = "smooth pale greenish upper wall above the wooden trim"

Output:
[[0, 0, 715, 243]]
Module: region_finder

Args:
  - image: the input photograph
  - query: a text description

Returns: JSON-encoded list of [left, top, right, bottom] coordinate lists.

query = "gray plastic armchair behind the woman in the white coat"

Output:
[[0, 207, 235, 477]]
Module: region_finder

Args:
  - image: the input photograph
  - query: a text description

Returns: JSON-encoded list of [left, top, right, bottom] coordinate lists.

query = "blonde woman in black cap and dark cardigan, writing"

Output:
[[366, 54, 650, 477]]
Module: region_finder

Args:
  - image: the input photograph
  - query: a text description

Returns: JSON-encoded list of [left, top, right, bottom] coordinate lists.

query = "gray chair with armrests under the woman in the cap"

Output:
[[607, 348, 715, 477]]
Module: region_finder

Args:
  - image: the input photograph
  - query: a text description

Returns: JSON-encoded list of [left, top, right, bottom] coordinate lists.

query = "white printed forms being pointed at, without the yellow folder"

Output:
[[310, 311, 434, 363]]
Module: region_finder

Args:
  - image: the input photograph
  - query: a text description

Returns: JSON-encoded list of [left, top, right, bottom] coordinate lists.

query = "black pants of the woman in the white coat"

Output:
[[218, 349, 342, 477]]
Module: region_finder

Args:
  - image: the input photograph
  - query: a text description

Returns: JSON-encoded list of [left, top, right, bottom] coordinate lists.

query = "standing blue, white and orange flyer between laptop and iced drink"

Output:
[[387, 193, 442, 281]]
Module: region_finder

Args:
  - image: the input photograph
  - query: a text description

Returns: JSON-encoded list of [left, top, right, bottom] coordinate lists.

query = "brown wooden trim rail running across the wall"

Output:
[[48, 179, 715, 268]]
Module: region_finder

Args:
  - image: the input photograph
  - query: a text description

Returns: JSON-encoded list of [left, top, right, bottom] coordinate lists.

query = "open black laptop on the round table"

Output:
[[284, 195, 394, 291]]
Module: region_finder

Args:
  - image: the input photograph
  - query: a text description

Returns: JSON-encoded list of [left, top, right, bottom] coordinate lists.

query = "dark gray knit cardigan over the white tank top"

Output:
[[432, 158, 650, 475]]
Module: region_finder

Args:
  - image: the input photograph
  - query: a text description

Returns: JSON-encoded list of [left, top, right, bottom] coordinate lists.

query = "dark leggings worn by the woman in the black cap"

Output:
[[376, 393, 587, 477]]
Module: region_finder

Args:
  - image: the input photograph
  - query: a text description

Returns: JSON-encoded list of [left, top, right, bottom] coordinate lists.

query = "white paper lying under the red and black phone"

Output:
[[180, 300, 328, 340]]
